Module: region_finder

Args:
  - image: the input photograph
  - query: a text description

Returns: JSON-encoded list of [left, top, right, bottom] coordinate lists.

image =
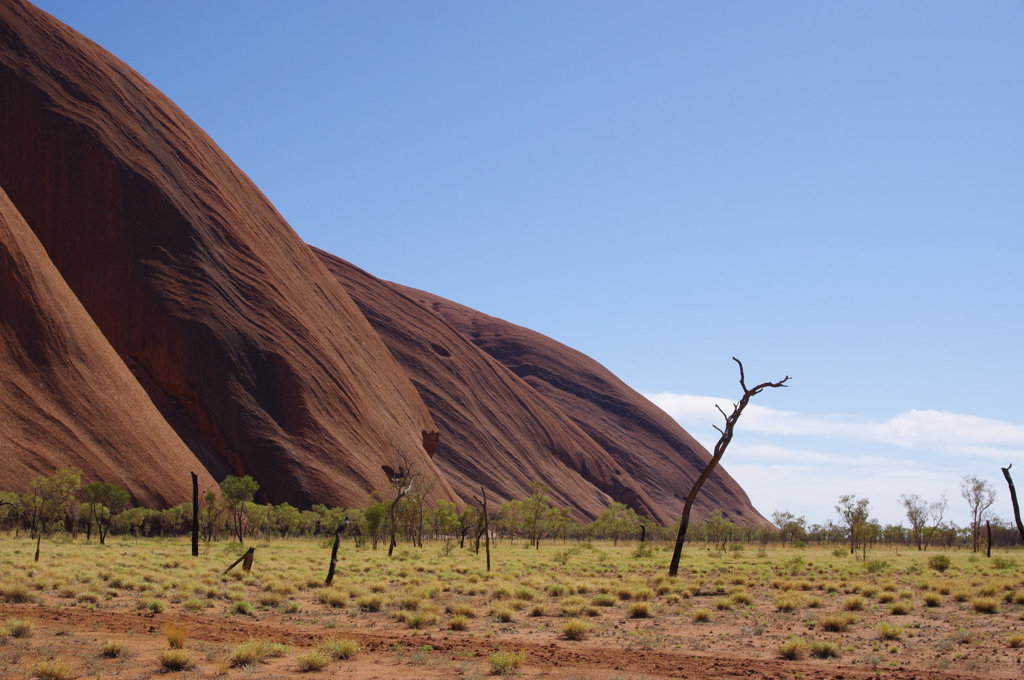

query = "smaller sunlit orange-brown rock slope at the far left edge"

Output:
[[0, 189, 213, 507]]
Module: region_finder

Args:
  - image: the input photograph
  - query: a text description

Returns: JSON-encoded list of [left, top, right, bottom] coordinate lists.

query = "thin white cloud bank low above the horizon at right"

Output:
[[646, 392, 1024, 525]]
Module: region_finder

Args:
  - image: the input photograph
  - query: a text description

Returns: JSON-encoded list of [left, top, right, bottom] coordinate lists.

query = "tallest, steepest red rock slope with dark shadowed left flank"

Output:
[[0, 0, 457, 505]]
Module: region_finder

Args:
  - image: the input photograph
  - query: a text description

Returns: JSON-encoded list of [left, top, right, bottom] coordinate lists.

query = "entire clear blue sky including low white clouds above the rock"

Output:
[[38, 0, 1024, 524]]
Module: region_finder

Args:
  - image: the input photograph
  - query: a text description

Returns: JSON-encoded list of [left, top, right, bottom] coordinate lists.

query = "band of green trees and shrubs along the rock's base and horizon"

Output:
[[0, 469, 1021, 550]]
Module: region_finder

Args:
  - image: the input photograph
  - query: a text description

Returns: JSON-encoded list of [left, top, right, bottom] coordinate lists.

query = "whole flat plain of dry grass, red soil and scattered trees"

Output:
[[0, 470, 1024, 679]]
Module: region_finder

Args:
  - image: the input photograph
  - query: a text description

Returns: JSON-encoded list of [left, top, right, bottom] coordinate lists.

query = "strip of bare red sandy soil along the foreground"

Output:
[[0, 604, 1021, 680]]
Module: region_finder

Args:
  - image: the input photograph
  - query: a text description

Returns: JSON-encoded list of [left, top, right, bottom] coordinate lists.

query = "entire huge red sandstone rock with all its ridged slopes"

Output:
[[0, 0, 764, 523]]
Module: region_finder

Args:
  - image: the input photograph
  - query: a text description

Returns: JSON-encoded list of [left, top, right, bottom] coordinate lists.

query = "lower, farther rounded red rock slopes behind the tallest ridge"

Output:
[[314, 249, 764, 523]]
